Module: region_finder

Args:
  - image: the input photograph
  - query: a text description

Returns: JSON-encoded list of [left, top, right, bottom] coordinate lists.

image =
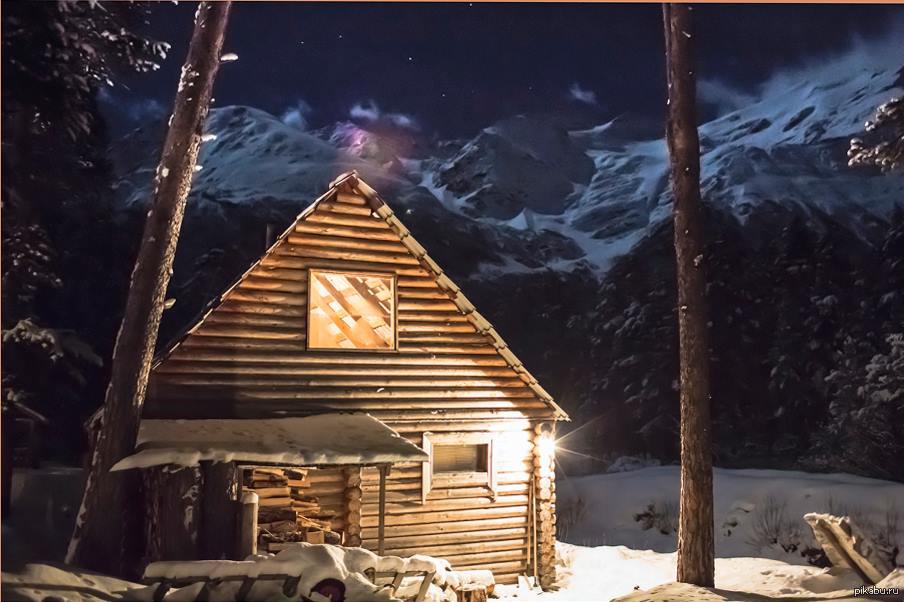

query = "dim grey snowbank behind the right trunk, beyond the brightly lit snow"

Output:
[[558, 466, 904, 565]]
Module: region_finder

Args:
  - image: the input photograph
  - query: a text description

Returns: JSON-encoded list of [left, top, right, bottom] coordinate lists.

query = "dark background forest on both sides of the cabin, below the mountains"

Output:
[[2, 3, 904, 480]]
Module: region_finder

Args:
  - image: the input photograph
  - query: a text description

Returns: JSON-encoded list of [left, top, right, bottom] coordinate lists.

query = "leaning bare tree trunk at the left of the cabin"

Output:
[[66, 2, 231, 574]]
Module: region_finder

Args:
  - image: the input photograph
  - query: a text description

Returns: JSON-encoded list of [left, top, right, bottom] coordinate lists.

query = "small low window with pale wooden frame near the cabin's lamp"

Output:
[[421, 433, 496, 503]]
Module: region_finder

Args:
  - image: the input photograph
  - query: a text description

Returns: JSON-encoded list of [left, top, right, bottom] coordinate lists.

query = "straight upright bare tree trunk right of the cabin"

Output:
[[663, 4, 714, 586]]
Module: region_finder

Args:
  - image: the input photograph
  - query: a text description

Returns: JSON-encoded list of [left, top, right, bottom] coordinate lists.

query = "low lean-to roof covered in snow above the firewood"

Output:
[[113, 413, 428, 470]]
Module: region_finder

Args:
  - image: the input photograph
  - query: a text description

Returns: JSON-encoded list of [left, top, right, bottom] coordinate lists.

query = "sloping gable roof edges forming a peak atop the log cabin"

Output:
[[153, 171, 570, 420]]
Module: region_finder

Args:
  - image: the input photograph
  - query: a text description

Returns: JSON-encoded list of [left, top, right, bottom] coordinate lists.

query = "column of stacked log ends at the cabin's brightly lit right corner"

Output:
[[533, 422, 556, 589]]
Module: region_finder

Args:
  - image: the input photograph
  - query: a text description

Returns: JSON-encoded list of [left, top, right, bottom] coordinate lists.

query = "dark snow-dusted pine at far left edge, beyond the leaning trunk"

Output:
[[2, 2, 167, 463]]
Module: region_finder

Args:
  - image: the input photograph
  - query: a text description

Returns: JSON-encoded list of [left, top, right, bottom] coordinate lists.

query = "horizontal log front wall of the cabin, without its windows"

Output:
[[145, 176, 561, 582]]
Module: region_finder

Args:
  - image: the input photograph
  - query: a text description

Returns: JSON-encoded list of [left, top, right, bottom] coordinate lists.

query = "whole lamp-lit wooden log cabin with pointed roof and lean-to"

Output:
[[111, 173, 567, 587]]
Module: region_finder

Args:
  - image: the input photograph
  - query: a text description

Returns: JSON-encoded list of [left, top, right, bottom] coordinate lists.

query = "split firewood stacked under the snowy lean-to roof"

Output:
[[244, 467, 342, 552]]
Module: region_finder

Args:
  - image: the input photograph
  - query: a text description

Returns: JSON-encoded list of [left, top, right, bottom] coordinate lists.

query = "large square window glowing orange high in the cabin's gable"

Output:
[[308, 270, 396, 350]]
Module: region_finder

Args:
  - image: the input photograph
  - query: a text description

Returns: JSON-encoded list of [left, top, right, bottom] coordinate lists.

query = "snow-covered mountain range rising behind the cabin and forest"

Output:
[[112, 50, 904, 276]]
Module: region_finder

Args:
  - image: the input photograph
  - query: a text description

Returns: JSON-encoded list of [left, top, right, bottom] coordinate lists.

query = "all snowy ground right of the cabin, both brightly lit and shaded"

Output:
[[499, 462, 904, 601]]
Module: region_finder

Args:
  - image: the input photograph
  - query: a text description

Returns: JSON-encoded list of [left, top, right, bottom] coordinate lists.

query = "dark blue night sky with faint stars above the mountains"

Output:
[[103, 2, 904, 137]]
